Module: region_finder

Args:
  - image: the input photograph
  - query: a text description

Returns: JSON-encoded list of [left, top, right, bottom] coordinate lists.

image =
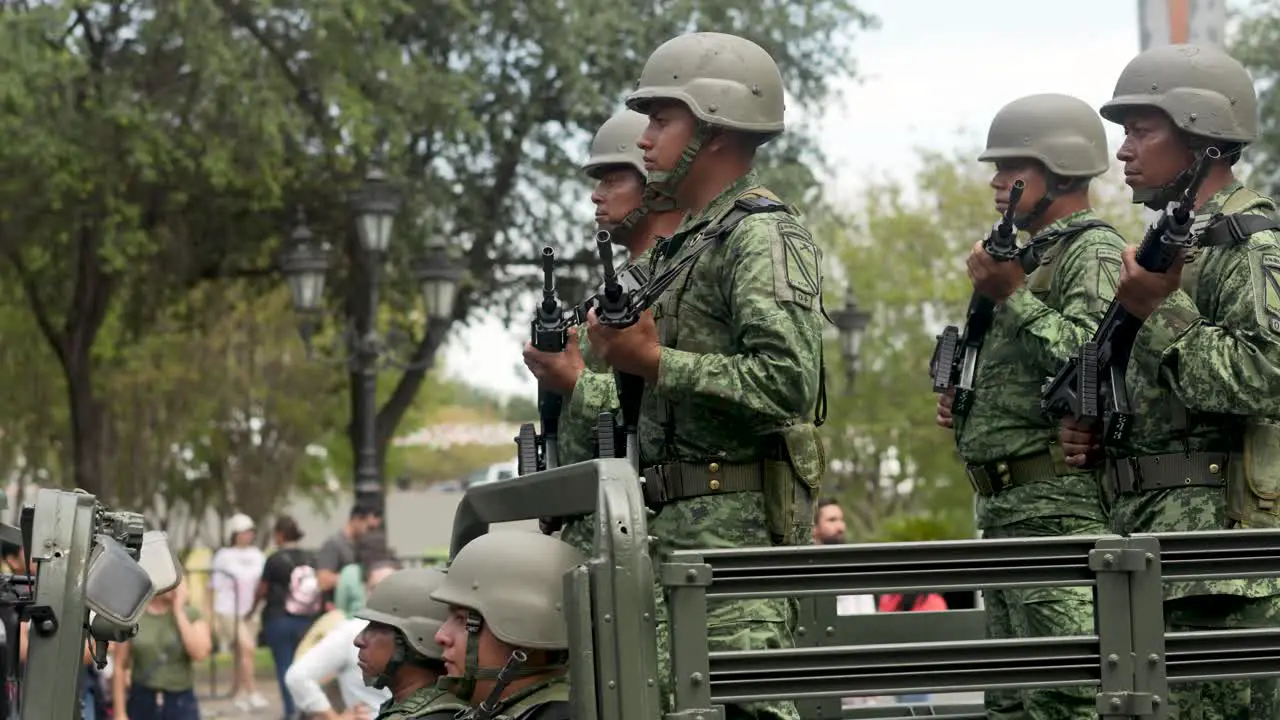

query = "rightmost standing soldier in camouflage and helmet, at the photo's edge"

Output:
[[1061, 45, 1280, 719]]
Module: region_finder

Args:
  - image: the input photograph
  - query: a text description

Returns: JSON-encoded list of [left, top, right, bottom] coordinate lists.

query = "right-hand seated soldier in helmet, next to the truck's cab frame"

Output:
[[431, 532, 586, 720]]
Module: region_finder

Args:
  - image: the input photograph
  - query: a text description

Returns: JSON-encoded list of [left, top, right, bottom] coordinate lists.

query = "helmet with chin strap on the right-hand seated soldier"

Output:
[[431, 532, 586, 700]]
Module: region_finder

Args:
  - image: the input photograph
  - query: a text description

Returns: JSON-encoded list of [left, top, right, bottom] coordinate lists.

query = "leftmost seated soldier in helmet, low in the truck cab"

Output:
[[355, 568, 466, 720]]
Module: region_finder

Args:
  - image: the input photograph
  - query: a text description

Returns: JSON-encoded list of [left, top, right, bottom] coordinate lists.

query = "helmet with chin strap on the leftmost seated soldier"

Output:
[[355, 568, 449, 688]]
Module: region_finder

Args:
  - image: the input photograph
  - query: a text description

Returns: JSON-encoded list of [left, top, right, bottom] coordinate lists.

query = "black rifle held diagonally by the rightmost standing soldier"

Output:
[[1041, 147, 1221, 447]]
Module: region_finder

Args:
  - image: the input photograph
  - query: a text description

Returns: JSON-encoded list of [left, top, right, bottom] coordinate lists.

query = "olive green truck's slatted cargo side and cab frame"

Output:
[[451, 459, 1280, 720]]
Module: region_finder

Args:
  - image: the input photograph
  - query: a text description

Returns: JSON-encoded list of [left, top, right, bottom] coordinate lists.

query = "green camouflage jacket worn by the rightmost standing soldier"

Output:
[[1110, 182, 1280, 597]]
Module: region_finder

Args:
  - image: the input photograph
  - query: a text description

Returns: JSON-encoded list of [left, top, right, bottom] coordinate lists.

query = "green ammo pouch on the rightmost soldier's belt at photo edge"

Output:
[[1226, 418, 1280, 528]]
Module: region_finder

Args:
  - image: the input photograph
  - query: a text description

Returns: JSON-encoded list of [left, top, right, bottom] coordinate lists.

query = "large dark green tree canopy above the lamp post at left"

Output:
[[0, 0, 869, 492]]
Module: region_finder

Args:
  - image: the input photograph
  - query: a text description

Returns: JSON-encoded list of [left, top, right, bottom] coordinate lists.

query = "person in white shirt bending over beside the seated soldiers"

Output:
[[284, 560, 399, 720]]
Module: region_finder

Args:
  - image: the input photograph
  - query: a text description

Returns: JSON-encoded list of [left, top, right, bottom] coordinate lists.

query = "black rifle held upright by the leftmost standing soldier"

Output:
[[516, 247, 568, 475]]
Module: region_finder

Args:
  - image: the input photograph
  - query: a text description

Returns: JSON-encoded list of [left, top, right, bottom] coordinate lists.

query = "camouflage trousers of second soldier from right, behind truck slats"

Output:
[[983, 516, 1107, 720]]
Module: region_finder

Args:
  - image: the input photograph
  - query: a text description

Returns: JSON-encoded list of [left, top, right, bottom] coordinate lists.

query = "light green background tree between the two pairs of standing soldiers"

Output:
[[818, 151, 1142, 539]]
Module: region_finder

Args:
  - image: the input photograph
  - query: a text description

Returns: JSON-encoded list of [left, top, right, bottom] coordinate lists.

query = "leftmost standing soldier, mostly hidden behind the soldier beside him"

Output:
[[525, 105, 681, 553]]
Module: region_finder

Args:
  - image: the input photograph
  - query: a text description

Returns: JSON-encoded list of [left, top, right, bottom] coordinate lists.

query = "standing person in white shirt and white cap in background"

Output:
[[209, 512, 269, 711]]
